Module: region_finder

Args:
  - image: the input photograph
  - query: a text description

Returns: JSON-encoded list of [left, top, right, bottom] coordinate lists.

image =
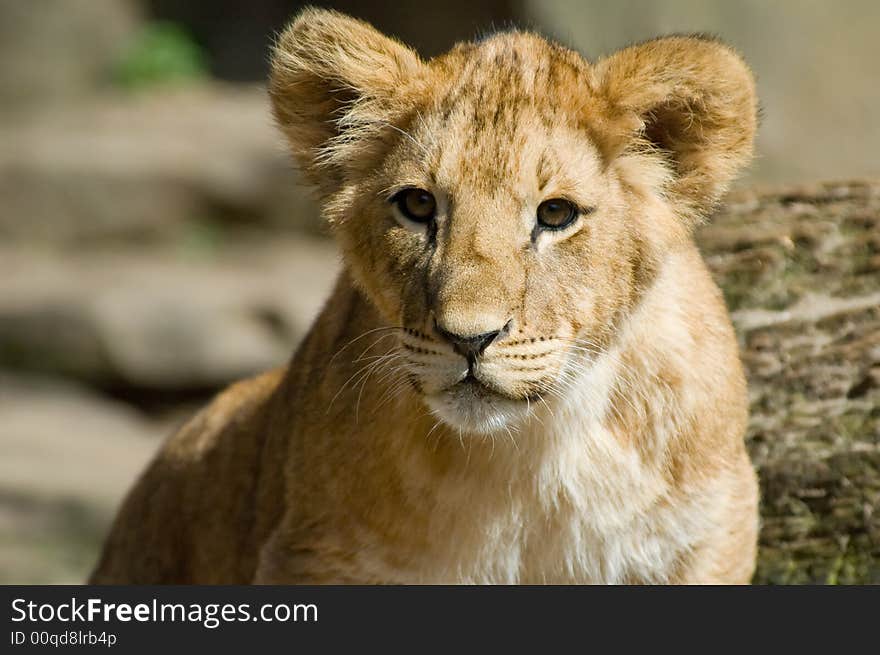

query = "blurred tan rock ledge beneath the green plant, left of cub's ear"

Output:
[[0, 84, 321, 243]]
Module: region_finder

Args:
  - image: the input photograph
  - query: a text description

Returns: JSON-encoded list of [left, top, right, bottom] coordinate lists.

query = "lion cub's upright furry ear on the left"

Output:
[[269, 8, 424, 191]]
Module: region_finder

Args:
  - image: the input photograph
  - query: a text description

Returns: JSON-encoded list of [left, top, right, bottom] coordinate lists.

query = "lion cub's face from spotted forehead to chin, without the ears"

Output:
[[360, 64, 639, 432]]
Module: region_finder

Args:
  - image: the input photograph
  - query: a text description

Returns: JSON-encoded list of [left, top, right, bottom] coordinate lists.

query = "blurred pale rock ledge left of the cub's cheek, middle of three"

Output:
[[0, 239, 336, 392]]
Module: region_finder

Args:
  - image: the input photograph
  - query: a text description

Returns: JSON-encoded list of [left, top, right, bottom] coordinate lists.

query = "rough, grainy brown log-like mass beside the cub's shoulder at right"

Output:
[[699, 182, 880, 584]]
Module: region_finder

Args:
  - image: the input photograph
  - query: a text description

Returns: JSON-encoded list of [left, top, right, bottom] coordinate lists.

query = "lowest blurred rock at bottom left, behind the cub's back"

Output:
[[0, 375, 167, 584]]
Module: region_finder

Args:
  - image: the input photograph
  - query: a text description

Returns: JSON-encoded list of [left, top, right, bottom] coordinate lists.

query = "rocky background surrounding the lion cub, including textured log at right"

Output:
[[0, 0, 880, 584]]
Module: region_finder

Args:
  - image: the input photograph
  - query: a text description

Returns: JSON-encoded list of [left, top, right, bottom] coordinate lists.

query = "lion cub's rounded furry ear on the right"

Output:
[[594, 36, 757, 219]]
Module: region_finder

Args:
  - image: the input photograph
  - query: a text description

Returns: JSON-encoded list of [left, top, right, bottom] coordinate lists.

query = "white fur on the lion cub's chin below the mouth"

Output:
[[425, 387, 528, 434]]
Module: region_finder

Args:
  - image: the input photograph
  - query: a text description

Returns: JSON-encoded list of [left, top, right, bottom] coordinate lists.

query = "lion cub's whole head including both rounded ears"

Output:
[[270, 10, 756, 433]]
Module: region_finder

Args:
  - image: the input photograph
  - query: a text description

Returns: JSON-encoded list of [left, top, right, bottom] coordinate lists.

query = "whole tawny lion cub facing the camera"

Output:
[[92, 9, 758, 583]]
